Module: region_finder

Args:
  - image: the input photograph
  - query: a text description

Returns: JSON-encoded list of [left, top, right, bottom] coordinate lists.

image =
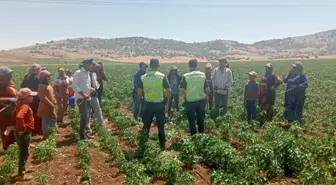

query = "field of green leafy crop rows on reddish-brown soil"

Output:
[[0, 60, 336, 185]]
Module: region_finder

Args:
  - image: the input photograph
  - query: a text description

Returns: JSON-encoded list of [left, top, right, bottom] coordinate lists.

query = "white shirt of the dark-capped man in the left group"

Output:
[[72, 67, 92, 100]]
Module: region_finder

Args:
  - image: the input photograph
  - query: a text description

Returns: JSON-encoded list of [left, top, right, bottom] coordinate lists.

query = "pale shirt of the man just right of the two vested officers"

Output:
[[212, 67, 233, 94]]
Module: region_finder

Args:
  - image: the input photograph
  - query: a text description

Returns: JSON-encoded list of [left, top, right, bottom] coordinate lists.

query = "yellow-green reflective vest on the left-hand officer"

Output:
[[141, 71, 164, 103]]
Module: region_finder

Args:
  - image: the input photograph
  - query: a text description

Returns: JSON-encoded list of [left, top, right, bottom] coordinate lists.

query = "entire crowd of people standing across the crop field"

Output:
[[0, 58, 308, 179]]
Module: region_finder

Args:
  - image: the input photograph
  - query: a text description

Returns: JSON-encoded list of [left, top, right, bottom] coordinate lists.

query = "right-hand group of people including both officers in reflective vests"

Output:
[[133, 58, 308, 150]]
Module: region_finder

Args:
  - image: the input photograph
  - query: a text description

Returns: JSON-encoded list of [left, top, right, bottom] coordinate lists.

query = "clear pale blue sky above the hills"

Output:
[[0, 0, 336, 50]]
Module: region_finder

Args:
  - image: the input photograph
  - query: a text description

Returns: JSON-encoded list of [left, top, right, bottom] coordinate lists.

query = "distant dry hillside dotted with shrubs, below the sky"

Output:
[[0, 30, 336, 61]]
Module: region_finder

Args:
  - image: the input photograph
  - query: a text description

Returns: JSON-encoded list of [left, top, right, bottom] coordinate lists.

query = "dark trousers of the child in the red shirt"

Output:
[[15, 131, 32, 175]]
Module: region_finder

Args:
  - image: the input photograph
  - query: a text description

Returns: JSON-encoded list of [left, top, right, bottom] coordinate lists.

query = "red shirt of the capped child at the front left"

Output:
[[13, 104, 34, 132]]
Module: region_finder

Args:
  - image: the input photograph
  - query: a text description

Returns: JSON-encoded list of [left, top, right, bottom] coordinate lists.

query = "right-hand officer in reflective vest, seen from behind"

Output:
[[181, 59, 210, 135]]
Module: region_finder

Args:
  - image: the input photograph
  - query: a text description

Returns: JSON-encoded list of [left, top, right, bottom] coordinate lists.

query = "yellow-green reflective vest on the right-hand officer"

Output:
[[184, 71, 206, 102]]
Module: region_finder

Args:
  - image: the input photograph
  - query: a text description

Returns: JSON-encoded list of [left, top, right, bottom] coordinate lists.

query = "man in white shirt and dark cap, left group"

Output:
[[72, 59, 95, 140]]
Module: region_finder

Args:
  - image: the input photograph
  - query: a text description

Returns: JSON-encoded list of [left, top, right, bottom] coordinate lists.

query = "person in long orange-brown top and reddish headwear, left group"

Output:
[[37, 70, 56, 137]]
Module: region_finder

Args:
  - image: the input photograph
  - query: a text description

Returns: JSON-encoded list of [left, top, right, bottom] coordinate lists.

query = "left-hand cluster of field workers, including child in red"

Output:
[[0, 59, 107, 179]]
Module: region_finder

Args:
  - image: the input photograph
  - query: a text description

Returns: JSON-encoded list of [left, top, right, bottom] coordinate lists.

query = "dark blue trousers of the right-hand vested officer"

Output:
[[187, 100, 205, 135]]
